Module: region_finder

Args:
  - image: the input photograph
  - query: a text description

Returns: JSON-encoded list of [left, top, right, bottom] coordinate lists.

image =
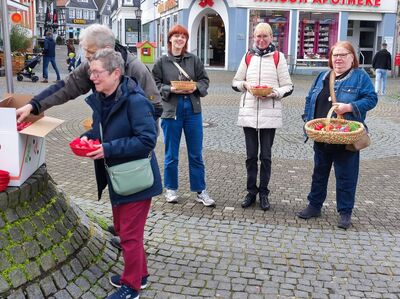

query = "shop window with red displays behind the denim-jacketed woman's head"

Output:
[[297, 12, 339, 62]]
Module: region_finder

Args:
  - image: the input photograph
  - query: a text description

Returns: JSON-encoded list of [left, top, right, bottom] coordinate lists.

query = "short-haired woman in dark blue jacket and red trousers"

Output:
[[81, 49, 162, 299]]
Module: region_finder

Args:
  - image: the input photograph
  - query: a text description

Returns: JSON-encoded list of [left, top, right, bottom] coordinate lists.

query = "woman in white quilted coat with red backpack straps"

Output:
[[232, 23, 293, 211]]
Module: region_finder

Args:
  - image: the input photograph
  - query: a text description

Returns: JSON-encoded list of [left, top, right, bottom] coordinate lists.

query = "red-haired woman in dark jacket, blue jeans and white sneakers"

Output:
[[153, 25, 215, 206]]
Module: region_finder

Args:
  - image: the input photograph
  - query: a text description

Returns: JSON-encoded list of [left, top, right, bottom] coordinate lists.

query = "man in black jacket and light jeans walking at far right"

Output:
[[372, 42, 392, 95]]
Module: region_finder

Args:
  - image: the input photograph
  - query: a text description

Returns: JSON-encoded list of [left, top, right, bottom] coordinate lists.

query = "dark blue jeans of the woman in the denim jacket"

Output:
[[307, 142, 360, 214]]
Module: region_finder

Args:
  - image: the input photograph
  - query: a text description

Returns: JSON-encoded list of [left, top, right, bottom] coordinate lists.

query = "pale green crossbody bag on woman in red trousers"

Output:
[[100, 124, 154, 196]]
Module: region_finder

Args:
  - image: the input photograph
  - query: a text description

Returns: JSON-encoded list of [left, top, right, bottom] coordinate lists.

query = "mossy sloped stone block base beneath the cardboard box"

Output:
[[0, 166, 119, 299]]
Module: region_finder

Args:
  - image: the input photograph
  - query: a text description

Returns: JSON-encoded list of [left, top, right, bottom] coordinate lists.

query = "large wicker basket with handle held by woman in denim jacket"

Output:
[[304, 106, 365, 144]]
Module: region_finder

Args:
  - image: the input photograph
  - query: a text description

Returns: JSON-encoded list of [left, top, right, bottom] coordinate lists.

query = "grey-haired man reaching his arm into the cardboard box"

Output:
[[17, 24, 162, 122]]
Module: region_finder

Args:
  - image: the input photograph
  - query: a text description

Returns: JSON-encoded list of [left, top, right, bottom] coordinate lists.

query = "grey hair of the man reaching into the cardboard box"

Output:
[[79, 24, 115, 49]]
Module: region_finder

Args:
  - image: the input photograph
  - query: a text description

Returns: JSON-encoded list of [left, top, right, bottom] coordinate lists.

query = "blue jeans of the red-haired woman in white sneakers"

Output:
[[161, 96, 206, 192]]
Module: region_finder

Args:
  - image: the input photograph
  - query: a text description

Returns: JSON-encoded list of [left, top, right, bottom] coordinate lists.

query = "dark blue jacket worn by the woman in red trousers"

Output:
[[83, 77, 162, 206]]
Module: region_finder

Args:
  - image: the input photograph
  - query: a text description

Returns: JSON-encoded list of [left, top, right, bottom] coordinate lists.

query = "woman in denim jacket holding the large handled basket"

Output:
[[297, 41, 378, 229]]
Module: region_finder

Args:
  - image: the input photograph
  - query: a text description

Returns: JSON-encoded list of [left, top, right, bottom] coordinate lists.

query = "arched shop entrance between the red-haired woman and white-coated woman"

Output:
[[197, 13, 225, 67]]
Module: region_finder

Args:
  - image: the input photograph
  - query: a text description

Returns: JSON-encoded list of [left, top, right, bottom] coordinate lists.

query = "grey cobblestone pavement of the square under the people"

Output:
[[0, 45, 400, 298]]
